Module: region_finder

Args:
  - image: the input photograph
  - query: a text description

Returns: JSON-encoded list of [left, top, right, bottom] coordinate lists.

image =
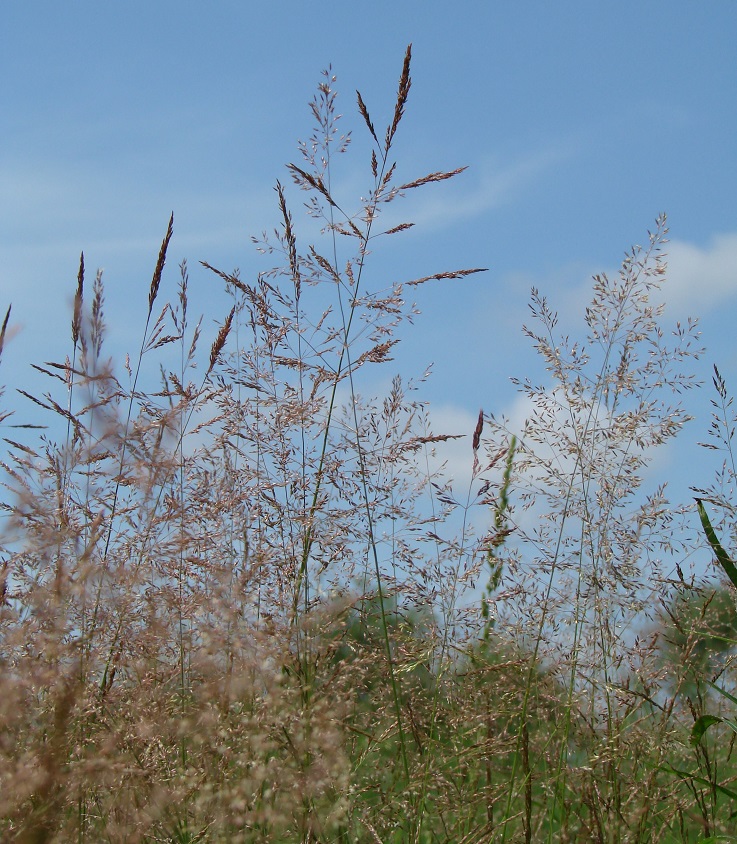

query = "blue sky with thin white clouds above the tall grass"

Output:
[[0, 0, 737, 520]]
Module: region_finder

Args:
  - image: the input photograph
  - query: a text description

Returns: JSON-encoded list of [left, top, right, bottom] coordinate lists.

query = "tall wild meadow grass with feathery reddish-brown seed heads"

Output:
[[0, 48, 737, 844]]
